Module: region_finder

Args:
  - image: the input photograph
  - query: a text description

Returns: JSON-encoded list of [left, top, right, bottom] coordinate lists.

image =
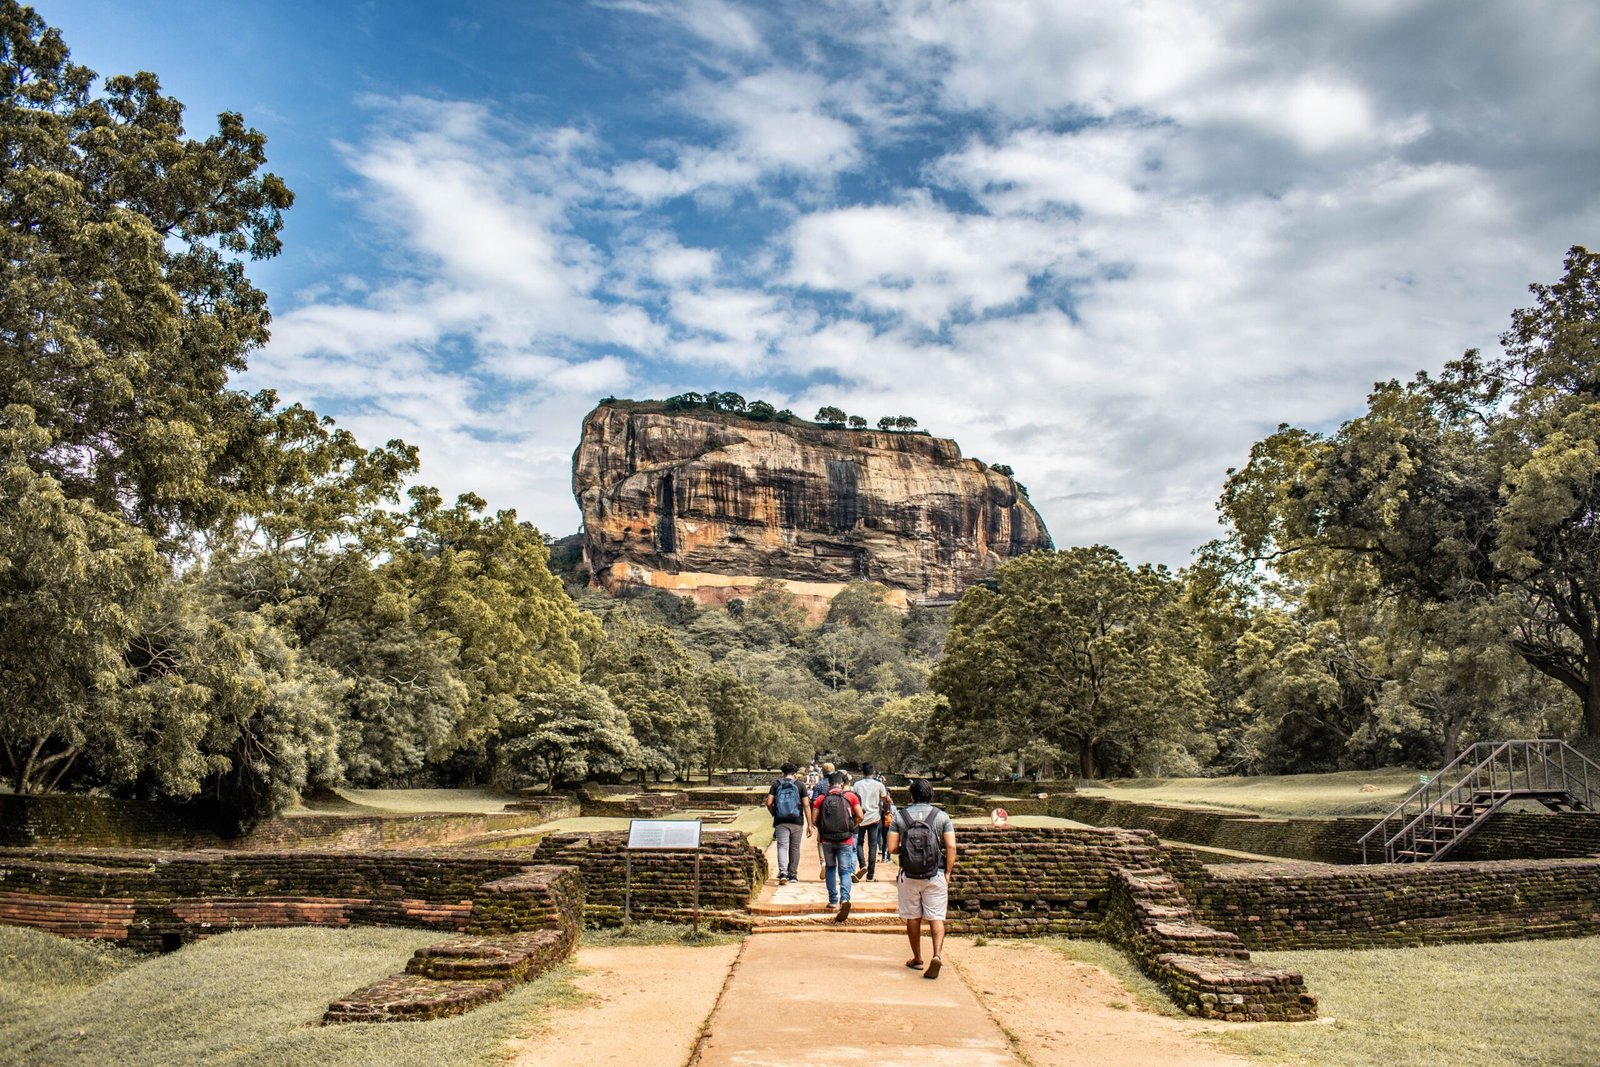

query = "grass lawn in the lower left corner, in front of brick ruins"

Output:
[[0, 926, 578, 1067]]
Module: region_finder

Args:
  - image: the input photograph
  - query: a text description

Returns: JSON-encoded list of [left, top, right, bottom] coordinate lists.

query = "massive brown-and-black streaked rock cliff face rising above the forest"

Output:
[[573, 402, 1051, 614]]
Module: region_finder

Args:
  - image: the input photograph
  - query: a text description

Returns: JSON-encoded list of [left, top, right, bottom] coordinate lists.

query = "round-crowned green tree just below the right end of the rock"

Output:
[[931, 545, 1206, 777]]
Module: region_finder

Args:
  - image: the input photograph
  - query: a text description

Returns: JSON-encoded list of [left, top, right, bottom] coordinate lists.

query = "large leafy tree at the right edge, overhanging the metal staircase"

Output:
[[1221, 248, 1600, 736]]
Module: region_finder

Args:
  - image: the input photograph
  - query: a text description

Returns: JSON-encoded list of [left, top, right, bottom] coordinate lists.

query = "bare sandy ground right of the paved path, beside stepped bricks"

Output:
[[949, 939, 1261, 1067]]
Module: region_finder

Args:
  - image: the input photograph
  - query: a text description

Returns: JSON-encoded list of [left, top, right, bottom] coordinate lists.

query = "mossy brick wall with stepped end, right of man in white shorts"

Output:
[[949, 827, 1317, 1022]]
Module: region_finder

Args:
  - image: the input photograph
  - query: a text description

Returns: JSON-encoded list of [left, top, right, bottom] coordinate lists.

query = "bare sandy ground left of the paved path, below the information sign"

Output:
[[512, 944, 741, 1067]]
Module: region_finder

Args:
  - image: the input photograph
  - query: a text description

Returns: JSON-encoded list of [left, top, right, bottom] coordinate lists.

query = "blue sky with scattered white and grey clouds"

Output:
[[35, 0, 1600, 566]]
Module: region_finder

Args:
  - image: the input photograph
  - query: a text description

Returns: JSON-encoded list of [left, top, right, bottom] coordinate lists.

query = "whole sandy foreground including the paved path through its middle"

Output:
[[514, 933, 1261, 1067]]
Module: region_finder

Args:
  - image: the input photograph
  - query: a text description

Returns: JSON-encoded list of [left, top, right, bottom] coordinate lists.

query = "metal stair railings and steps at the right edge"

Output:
[[1357, 737, 1600, 864]]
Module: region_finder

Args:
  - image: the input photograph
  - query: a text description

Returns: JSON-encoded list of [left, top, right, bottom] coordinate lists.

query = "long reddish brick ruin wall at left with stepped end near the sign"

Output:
[[0, 849, 584, 1022]]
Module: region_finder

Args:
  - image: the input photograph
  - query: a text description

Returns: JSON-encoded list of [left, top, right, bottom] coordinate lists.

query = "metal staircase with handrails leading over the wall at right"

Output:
[[1360, 741, 1600, 864]]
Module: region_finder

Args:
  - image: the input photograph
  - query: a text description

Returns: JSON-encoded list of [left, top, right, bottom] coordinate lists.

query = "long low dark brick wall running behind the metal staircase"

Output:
[[1043, 795, 1600, 864]]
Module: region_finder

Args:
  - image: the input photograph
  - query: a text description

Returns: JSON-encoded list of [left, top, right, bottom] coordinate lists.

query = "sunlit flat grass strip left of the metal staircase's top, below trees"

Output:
[[1078, 766, 1418, 816]]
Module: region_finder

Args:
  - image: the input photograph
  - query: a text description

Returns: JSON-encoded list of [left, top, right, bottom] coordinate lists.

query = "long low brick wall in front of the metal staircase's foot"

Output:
[[1178, 859, 1600, 950]]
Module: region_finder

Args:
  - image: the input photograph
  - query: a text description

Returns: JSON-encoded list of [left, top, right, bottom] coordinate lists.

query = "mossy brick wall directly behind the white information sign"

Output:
[[533, 830, 766, 928]]
